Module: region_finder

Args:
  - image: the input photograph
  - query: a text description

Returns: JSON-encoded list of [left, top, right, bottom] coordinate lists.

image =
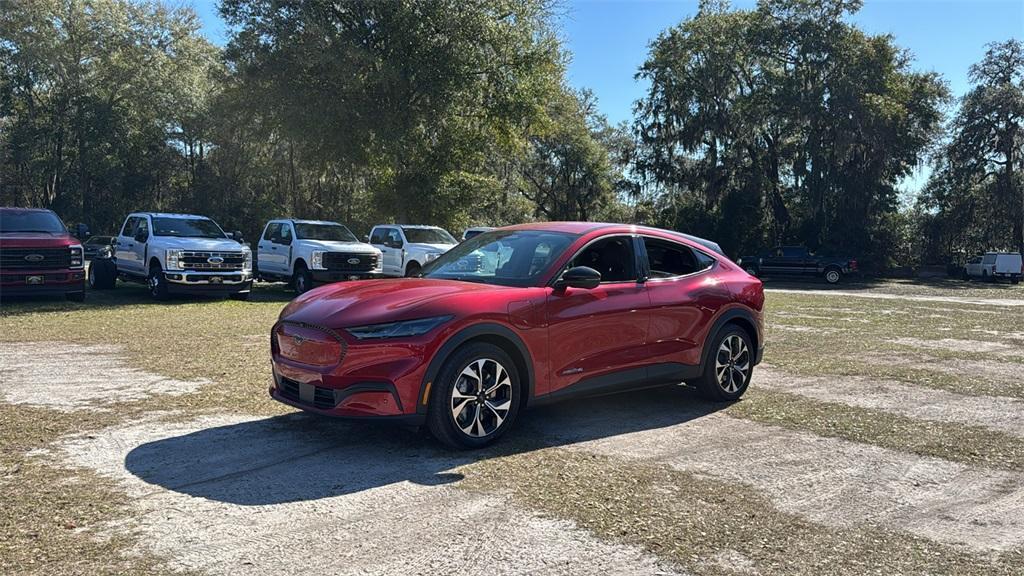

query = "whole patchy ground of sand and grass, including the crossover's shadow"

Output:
[[0, 284, 1024, 576]]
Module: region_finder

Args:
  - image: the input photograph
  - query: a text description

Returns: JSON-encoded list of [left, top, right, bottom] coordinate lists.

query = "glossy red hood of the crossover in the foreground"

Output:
[[281, 278, 507, 328]]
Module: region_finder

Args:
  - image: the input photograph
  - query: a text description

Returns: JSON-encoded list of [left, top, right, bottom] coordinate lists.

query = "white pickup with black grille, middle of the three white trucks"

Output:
[[256, 219, 383, 294]]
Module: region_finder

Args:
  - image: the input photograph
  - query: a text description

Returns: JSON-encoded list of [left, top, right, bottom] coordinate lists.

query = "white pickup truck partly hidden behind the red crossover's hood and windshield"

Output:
[[370, 224, 459, 277]]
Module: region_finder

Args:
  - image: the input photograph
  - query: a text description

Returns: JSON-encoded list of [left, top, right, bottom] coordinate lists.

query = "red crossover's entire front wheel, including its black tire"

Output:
[[427, 342, 525, 450]]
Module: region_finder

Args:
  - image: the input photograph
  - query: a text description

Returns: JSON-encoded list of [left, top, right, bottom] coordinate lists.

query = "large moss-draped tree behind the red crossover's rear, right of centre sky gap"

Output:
[[636, 0, 947, 260]]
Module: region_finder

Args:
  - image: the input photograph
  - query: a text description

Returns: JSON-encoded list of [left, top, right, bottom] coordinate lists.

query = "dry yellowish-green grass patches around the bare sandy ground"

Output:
[[0, 282, 1024, 575]]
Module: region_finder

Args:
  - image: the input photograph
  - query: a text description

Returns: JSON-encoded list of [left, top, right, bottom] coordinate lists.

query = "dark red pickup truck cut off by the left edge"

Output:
[[0, 207, 85, 302]]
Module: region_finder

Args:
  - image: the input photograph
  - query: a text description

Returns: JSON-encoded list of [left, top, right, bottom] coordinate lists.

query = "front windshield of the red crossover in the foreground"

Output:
[[421, 230, 578, 286]]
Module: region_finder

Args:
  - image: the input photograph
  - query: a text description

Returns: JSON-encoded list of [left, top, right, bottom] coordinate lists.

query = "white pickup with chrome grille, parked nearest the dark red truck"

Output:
[[89, 212, 253, 300]]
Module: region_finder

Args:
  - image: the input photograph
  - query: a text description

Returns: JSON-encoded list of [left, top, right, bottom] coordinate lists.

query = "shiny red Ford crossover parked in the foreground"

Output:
[[270, 222, 764, 448]]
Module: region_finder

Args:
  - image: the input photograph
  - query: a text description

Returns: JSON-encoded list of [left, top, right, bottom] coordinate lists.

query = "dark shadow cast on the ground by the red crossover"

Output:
[[125, 386, 728, 505]]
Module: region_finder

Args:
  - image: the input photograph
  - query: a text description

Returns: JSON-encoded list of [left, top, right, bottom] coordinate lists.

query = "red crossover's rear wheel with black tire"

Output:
[[693, 324, 756, 402]]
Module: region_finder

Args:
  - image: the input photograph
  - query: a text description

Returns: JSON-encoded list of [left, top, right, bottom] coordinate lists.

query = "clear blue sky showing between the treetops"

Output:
[[193, 0, 1024, 190]]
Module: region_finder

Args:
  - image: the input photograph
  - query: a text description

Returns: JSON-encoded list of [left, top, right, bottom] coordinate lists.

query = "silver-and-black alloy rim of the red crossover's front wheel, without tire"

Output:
[[451, 358, 513, 438]]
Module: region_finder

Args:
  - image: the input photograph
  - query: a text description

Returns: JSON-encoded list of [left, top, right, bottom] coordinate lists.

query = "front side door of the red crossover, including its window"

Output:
[[537, 235, 650, 394]]
